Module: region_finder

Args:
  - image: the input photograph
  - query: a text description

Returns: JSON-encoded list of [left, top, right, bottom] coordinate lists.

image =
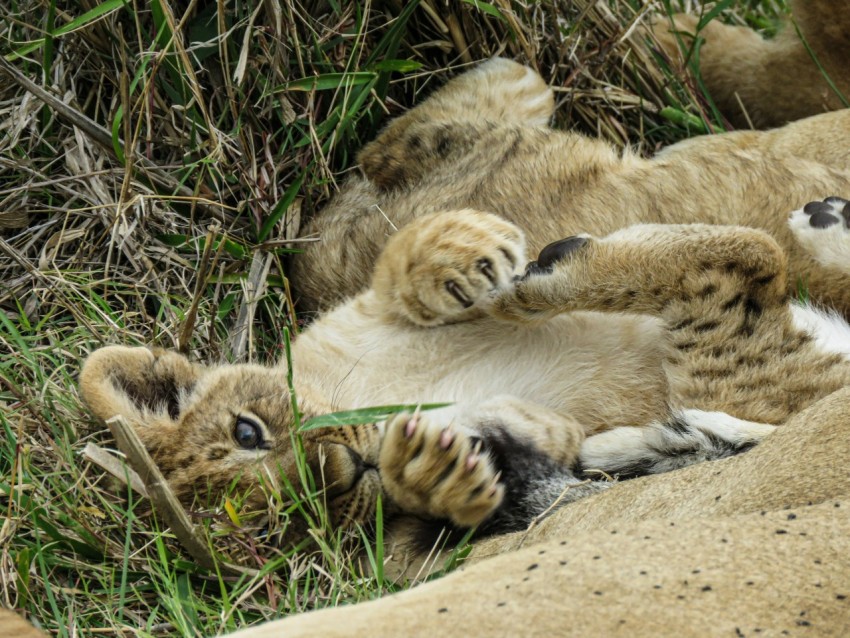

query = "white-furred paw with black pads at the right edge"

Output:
[[788, 197, 850, 271]]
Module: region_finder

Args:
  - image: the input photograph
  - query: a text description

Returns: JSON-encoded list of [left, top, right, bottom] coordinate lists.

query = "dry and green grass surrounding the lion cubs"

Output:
[[0, 0, 782, 636]]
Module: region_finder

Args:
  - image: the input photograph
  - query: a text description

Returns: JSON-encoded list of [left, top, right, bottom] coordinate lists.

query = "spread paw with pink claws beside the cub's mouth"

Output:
[[379, 413, 504, 527]]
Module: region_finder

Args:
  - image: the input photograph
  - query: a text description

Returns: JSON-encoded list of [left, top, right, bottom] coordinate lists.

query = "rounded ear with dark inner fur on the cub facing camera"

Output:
[[80, 346, 204, 432]]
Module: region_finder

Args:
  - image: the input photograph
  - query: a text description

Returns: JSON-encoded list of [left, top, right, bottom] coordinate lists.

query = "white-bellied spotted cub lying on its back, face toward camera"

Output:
[[80, 198, 850, 551]]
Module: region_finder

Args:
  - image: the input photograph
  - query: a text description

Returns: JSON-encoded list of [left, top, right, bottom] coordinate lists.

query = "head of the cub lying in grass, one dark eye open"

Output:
[[80, 346, 381, 541]]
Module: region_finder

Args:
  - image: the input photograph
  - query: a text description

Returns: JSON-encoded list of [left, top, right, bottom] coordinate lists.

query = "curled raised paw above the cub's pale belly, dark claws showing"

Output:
[[373, 210, 525, 326]]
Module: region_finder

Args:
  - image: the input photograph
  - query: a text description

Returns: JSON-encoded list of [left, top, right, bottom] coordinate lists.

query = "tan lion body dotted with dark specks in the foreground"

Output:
[[227, 389, 850, 638]]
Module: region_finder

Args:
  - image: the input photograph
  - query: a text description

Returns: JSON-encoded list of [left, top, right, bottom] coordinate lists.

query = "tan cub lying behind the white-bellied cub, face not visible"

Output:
[[292, 58, 850, 316]]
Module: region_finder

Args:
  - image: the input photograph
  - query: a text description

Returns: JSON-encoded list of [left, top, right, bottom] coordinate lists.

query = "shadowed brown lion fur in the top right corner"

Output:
[[653, 0, 850, 128]]
